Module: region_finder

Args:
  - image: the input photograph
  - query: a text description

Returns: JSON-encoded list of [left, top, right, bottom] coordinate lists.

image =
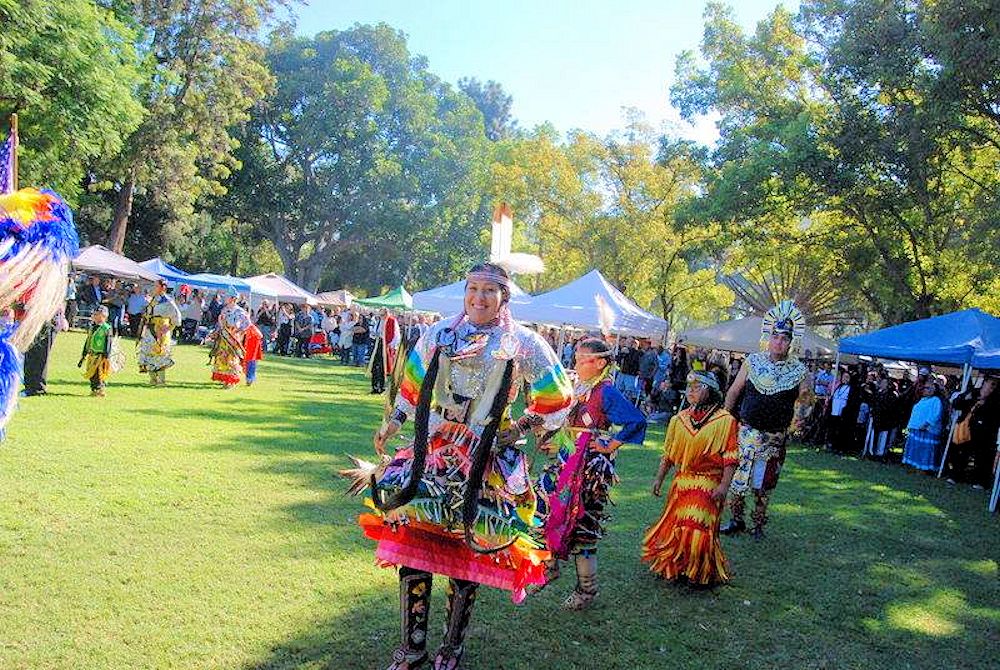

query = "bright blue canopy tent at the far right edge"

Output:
[[838, 308, 1000, 489]]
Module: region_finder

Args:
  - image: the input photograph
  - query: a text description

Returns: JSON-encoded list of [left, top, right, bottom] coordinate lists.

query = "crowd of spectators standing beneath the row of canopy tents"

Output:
[[65, 276, 1000, 496]]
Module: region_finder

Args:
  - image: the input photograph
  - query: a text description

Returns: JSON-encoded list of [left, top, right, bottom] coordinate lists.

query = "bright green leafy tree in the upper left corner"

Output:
[[0, 0, 143, 204]]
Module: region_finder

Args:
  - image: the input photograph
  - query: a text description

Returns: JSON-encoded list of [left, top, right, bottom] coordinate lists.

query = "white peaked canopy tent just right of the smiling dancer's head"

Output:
[[514, 270, 667, 337]]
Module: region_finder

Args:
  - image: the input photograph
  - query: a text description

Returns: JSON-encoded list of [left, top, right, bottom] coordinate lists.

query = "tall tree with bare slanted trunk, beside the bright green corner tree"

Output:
[[96, 0, 285, 251]]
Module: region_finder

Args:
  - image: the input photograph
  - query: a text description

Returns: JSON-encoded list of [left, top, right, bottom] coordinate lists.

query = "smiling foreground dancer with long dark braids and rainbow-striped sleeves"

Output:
[[343, 263, 572, 670]]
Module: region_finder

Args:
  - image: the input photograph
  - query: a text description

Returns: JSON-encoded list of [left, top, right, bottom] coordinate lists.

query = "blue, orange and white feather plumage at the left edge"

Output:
[[0, 188, 79, 431]]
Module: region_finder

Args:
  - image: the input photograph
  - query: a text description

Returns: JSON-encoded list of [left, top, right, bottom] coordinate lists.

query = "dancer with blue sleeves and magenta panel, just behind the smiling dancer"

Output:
[[539, 338, 646, 610]]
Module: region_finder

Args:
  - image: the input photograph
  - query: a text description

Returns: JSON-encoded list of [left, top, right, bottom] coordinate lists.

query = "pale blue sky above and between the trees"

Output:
[[295, 0, 798, 143]]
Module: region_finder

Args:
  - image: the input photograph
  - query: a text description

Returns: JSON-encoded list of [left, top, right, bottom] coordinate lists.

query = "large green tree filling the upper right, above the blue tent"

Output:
[[673, 0, 998, 322]]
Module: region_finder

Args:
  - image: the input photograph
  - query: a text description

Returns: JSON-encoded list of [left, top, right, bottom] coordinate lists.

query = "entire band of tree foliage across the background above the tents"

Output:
[[0, 0, 1000, 328]]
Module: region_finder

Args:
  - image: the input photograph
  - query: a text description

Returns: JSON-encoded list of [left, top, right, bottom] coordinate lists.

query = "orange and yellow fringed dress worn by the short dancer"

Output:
[[642, 408, 739, 584]]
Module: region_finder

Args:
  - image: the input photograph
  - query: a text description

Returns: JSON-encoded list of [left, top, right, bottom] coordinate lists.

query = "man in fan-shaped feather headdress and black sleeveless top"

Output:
[[721, 300, 806, 539]]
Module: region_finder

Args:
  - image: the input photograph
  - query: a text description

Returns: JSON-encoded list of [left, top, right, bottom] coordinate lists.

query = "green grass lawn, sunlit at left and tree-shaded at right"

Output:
[[0, 333, 1000, 670]]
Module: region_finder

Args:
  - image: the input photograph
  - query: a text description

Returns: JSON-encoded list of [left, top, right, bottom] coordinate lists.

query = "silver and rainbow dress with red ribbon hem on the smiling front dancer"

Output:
[[359, 316, 572, 602]]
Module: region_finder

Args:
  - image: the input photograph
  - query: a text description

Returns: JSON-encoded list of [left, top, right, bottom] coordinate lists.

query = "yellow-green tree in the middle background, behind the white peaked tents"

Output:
[[492, 120, 733, 330]]
